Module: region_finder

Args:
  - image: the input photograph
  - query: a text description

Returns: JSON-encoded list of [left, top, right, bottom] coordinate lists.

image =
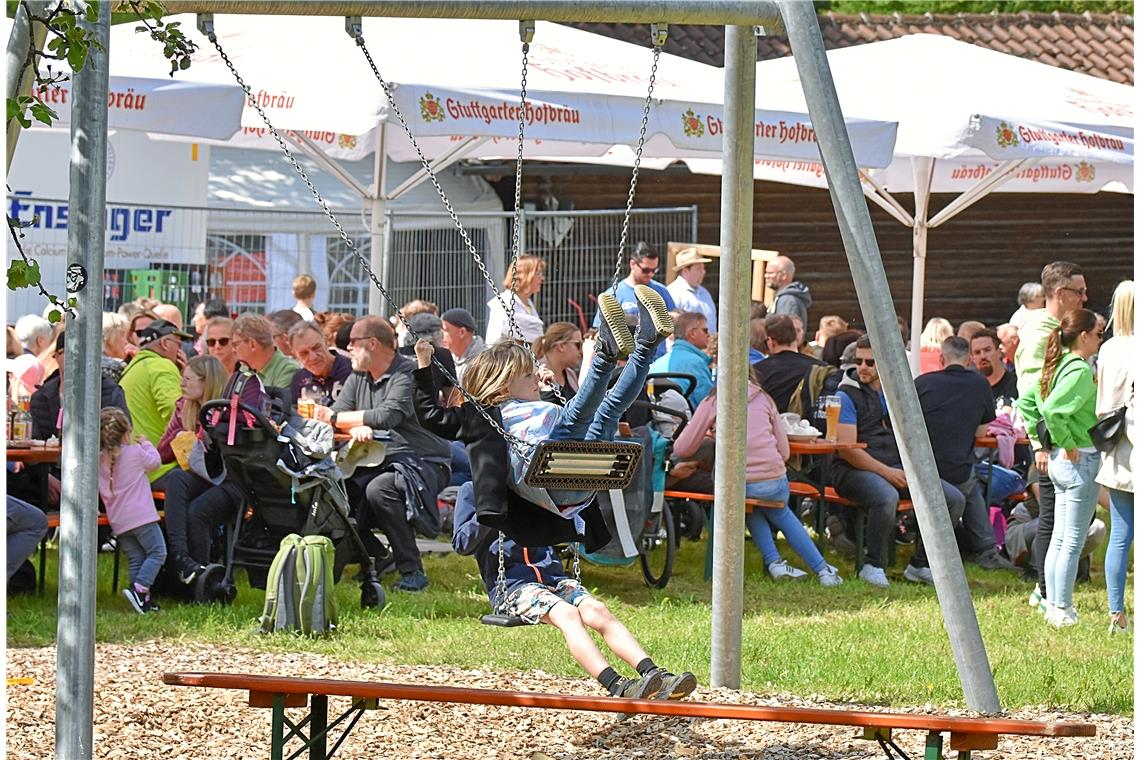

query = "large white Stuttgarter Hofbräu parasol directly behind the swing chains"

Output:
[[111, 15, 895, 309]]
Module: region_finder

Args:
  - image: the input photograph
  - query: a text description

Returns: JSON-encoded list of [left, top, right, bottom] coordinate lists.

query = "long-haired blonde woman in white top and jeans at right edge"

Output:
[[1097, 280, 1137, 634]]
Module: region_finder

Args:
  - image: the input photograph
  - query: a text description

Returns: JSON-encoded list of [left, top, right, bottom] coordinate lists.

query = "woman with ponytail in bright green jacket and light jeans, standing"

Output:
[[1018, 309, 1101, 628]]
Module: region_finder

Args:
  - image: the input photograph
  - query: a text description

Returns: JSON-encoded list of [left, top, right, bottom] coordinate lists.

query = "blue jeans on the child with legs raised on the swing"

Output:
[[547, 342, 654, 506]]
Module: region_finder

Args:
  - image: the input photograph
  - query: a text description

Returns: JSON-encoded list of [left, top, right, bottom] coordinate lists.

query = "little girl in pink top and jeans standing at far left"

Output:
[[99, 407, 166, 614]]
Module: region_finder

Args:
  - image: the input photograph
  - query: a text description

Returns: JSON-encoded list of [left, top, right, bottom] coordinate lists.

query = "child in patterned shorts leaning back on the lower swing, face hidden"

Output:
[[451, 482, 697, 700]]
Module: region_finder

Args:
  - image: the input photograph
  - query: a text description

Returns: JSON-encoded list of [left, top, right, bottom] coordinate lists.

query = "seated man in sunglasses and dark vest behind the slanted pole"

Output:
[[834, 335, 966, 588]]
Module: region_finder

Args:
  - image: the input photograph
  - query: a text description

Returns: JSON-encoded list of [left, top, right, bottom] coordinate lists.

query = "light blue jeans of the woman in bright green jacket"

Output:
[[1037, 448, 1100, 607]]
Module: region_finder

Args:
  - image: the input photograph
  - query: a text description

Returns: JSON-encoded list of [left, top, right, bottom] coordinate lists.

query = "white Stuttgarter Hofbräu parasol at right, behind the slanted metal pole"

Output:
[[686, 34, 1135, 369]]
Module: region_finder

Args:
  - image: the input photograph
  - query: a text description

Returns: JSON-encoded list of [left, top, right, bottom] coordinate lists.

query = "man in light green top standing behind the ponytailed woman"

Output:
[[1013, 261, 1089, 612]]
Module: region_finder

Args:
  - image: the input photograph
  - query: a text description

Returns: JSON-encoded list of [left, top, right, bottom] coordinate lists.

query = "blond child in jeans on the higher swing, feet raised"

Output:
[[415, 285, 673, 524]]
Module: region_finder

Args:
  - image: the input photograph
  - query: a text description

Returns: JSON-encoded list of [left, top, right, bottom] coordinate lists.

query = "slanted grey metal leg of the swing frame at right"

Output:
[[779, 0, 1001, 714]]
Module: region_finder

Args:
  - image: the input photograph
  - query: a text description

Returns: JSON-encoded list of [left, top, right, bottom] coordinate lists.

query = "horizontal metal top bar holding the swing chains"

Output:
[[165, 0, 783, 27]]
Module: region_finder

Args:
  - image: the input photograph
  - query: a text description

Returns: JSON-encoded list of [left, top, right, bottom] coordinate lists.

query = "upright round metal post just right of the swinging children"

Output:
[[710, 26, 756, 688]]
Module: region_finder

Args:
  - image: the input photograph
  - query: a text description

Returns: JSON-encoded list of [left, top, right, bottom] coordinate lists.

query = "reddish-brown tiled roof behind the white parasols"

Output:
[[572, 13, 1135, 85]]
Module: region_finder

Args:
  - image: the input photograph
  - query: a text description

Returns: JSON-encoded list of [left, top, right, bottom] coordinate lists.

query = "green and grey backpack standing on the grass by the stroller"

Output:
[[259, 533, 336, 636]]
